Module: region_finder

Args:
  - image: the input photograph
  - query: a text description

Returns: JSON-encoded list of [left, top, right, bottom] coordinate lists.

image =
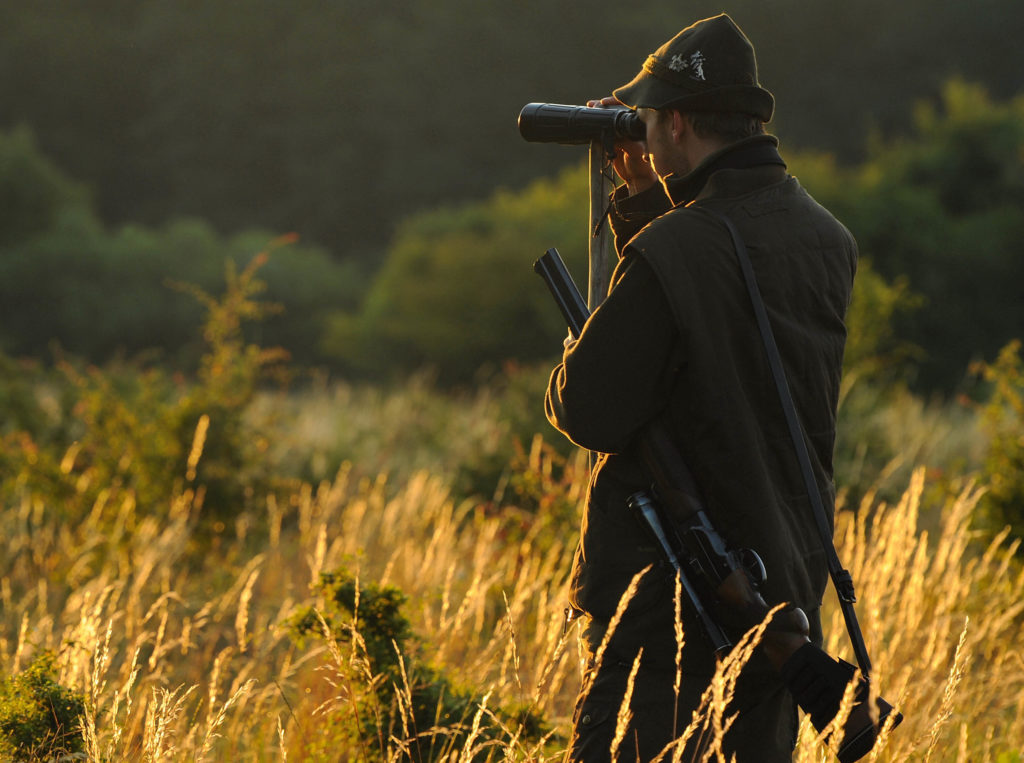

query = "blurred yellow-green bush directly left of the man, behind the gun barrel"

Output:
[[326, 168, 587, 383]]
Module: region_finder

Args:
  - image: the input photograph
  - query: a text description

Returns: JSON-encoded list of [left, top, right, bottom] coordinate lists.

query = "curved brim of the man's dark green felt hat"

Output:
[[612, 70, 775, 122]]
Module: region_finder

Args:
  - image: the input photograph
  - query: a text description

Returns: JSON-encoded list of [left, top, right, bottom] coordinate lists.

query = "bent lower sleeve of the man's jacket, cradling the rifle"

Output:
[[545, 257, 682, 453]]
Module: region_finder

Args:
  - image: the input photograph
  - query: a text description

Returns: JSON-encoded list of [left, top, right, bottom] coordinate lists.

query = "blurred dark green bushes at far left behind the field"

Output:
[[0, 126, 362, 364]]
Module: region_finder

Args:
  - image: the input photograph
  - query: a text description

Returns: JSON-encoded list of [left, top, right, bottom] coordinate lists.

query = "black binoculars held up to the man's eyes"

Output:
[[519, 103, 647, 145]]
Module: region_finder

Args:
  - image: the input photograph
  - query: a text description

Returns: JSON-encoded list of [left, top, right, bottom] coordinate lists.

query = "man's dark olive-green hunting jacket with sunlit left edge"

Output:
[[546, 136, 857, 662]]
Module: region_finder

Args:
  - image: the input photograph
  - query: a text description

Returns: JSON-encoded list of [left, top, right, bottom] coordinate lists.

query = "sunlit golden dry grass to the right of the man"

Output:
[[797, 469, 1024, 762]]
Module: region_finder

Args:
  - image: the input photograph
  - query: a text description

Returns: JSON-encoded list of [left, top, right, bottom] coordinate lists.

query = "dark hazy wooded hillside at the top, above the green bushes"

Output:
[[0, 0, 1024, 260]]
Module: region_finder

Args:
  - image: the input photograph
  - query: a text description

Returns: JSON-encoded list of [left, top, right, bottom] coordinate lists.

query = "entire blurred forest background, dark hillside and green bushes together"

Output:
[[0, 0, 1024, 392]]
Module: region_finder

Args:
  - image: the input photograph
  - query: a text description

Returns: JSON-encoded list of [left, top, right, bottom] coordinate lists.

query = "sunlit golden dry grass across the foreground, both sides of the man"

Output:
[[0, 419, 1024, 763]]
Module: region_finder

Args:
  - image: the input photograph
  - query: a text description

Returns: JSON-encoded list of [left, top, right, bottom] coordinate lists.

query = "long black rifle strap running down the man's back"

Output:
[[697, 207, 871, 678]]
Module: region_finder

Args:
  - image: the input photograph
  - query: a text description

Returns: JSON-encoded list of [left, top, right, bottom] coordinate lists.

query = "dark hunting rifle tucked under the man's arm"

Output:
[[534, 249, 902, 763]]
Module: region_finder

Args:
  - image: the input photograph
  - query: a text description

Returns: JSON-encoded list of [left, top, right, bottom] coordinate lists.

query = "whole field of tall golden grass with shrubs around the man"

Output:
[[0, 264, 1024, 763]]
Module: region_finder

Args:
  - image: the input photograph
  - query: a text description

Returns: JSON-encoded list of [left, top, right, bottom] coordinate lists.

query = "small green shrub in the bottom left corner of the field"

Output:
[[0, 652, 85, 763]]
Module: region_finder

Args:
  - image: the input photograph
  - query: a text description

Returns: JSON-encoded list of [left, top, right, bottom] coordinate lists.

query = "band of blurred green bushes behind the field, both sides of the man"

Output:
[[0, 81, 1024, 393]]
